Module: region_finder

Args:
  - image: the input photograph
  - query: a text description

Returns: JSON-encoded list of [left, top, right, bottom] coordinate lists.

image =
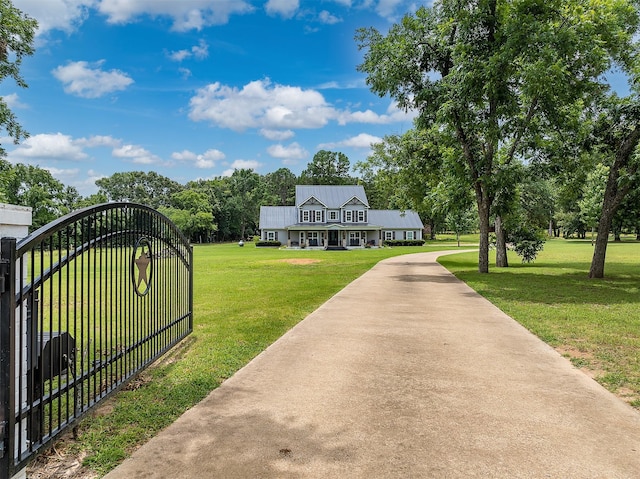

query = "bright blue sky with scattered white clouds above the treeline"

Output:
[[0, 0, 624, 195]]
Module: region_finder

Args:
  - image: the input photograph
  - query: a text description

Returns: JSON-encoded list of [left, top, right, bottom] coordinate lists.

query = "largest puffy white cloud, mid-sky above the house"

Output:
[[189, 79, 338, 131]]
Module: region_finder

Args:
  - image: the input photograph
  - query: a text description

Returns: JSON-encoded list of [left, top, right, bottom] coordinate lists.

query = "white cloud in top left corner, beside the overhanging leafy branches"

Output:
[[19, 0, 97, 35]]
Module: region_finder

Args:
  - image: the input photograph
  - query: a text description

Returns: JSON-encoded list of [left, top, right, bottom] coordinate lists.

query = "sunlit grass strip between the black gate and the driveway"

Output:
[[60, 242, 455, 475]]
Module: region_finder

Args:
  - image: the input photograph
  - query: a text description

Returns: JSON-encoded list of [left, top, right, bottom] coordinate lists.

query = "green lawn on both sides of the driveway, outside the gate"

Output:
[[42, 237, 640, 474]]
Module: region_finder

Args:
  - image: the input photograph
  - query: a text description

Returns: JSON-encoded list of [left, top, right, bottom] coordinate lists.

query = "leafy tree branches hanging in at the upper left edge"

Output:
[[0, 0, 38, 158]]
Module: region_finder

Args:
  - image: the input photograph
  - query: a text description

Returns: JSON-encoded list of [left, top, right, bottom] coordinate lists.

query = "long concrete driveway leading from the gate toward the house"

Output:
[[106, 252, 640, 479]]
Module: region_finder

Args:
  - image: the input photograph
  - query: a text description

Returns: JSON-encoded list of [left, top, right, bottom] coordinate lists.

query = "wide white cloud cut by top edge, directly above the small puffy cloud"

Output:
[[98, 0, 253, 31]]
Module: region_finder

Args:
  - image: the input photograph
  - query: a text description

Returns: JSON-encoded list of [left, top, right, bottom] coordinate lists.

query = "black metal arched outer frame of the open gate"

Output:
[[0, 202, 193, 479]]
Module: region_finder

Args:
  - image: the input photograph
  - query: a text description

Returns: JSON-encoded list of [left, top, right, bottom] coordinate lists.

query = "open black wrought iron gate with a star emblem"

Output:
[[0, 203, 193, 479]]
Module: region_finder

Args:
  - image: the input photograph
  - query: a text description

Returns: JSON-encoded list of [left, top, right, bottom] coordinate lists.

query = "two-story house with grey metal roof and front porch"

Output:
[[259, 185, 423, 248]]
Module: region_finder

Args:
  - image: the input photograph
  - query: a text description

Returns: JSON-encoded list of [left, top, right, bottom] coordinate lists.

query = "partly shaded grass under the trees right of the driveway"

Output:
[[440, 240, 640, 408]]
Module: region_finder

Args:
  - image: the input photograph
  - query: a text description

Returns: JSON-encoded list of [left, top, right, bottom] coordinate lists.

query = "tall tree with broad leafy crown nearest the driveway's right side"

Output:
[[356, 0, 638, 273]]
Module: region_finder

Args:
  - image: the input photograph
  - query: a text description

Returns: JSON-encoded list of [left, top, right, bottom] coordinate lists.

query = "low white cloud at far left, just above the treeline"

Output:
[[7, 133, 87, 162]]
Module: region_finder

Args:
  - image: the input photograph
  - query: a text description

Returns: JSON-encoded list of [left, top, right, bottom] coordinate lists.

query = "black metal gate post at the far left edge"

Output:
[[0, 238, 16, 479]]
